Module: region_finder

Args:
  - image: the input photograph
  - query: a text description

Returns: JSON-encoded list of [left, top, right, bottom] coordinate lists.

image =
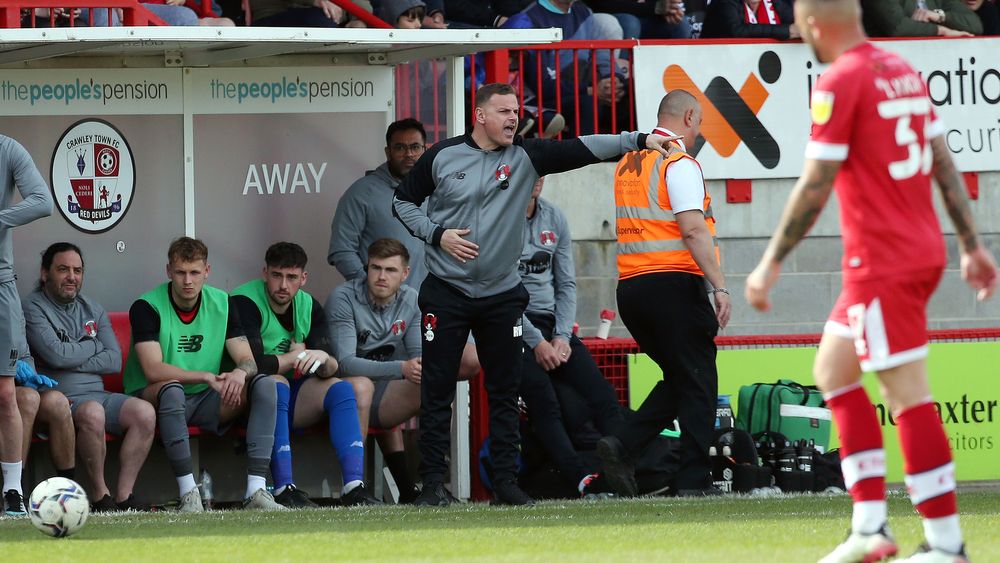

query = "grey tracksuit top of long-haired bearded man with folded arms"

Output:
[[23, 289, 122, 395]]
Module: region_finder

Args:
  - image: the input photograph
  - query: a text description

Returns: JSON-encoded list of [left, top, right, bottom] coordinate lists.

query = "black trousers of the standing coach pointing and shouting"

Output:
[[418, 275, 528, 486]]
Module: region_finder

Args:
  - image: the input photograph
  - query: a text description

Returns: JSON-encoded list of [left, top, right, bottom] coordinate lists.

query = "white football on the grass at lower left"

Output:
[[28, 477, 90, 538]]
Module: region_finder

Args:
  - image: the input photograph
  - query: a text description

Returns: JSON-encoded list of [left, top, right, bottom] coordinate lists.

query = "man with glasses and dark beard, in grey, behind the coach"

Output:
[[327, 118, 427, 289]]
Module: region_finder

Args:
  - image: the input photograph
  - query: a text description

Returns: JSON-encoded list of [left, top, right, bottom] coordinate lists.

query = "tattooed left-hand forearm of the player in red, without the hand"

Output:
[[765, 160, 841, 263]]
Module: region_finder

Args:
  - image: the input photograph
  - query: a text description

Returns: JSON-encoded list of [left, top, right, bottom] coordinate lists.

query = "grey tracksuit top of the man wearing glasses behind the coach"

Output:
[[326, 162, 427, 288]]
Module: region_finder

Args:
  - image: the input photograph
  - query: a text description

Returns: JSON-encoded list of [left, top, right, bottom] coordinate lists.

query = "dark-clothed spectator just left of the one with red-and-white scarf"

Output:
[[587, 0, 691, 39]]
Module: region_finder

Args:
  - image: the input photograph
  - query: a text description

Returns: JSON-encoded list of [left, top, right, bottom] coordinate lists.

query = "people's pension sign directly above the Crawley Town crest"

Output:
[[0, 68, 184, 116]]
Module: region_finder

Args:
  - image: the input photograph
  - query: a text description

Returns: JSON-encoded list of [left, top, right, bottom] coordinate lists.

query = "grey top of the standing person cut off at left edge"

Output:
[[0, 135, 52, 283]]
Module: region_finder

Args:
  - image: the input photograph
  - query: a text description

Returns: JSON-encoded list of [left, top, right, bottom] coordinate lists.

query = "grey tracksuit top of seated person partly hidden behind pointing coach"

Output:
[[518, 198, 576, 348]]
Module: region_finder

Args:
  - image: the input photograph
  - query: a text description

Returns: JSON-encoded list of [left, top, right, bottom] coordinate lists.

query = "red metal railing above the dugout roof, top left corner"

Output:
[[0, 0, 167, 28]]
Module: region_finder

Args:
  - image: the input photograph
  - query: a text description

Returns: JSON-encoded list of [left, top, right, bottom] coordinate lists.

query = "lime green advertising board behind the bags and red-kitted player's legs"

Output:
[[629, 342, 1000, 483]]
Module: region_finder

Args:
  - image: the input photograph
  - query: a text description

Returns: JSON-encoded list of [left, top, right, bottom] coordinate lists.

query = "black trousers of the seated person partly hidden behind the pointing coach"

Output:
[[518, 315, 623, 486]]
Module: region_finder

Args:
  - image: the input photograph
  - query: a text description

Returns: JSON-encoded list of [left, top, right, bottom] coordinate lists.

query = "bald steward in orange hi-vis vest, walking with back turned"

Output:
[[597, 90, 731, 502]]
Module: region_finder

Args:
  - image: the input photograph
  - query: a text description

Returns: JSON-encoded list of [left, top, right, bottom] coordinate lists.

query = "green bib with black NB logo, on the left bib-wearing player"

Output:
[[124, 283, 229, 395]]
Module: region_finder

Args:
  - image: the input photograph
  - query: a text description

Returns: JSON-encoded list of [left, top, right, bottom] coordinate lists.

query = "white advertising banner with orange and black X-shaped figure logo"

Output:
[[634, 38, 1000, 179]]
